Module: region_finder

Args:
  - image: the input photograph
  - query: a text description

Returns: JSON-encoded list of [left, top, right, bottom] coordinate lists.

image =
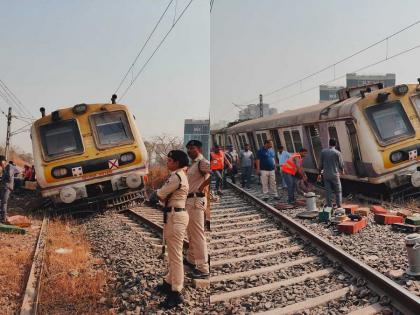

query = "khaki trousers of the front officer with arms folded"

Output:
[[163, 211, 188, 292]]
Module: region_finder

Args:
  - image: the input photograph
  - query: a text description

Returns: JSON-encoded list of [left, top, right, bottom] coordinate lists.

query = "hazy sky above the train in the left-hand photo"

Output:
[[0, 0, 210, 151]]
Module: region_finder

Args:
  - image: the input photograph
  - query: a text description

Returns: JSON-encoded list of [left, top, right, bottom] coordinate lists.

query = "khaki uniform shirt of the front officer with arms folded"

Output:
[[157, 169, 189, 208]]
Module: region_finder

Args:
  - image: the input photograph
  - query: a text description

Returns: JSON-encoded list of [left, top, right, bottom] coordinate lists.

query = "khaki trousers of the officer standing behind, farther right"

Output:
[[185, 197, 209, 272]]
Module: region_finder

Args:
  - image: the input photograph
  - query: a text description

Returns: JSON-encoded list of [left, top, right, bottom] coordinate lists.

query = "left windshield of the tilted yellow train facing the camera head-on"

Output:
[[39, 120, 83, 158]]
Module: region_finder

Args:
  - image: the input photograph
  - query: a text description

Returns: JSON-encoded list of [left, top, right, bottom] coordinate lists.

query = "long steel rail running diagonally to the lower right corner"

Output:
[[227, 182, 420, 315]]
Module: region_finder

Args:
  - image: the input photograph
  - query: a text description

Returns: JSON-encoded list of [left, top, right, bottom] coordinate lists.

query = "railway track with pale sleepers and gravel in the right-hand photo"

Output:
[[210, 184, 420, 314]]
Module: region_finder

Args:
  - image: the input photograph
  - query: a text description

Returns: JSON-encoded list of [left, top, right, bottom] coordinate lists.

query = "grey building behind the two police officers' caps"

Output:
[[184, 119, 210, 159]]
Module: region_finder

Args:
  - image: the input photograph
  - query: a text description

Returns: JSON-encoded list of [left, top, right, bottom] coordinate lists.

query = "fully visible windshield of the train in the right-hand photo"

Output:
[[366, 101, 414, 142]]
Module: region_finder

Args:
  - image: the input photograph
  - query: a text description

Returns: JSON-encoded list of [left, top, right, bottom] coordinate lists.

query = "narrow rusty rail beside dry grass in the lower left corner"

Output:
[[20, 216, 49, 315]]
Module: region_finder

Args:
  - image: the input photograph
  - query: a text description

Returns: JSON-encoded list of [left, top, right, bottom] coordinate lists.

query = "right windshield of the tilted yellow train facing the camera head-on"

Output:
[[91, 111, 133, 146]]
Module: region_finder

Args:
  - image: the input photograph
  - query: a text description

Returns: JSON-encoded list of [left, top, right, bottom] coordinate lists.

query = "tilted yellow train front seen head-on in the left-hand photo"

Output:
[[31, 104, 148, 206]]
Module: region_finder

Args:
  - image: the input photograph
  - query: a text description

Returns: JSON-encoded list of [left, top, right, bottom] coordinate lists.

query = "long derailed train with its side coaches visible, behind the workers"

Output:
[[211, 80, 420, 192]]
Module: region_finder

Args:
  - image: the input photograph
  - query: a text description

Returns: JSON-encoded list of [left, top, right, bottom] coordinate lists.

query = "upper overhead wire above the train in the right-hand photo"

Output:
[[238, 20, 420, 103]]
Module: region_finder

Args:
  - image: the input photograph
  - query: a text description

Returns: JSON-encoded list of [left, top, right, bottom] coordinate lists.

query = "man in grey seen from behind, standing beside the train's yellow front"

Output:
[[318, 138, 344, 208]]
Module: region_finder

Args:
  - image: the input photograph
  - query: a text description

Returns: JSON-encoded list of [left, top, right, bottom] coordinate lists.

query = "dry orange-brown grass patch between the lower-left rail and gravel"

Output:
[[40, 221, 109, 314]]
